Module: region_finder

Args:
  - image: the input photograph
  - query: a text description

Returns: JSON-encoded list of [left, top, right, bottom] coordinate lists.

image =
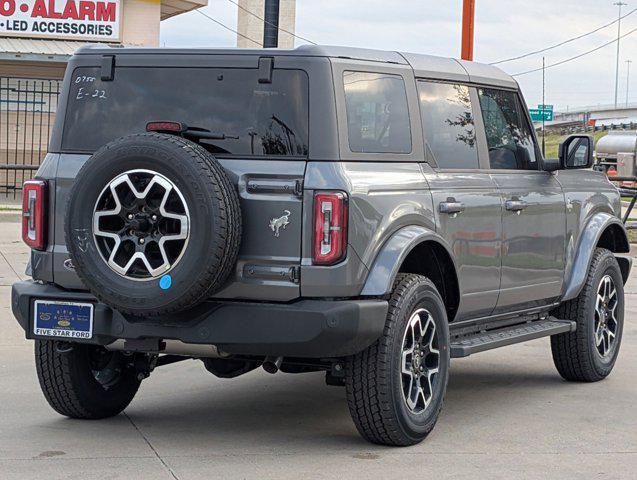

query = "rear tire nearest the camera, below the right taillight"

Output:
[[345, 274, 449, 446]]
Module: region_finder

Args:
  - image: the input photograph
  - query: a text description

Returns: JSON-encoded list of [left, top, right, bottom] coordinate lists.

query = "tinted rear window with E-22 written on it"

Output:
[[62, 68, 308, 156]]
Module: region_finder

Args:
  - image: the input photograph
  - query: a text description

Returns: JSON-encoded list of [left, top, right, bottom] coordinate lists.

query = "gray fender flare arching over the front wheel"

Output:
[[562, 212, 630, 301]]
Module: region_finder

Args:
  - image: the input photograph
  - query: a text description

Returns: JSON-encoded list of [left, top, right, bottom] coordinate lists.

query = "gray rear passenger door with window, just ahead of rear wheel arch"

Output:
[[418, 80, 502, 320]]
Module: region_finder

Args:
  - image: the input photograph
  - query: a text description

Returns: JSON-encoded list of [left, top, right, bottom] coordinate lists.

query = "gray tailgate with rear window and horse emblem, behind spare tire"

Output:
[[44, 61, 308, 301]]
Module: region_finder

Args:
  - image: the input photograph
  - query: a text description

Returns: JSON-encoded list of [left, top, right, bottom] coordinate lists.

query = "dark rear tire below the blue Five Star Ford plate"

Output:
[[35, 340, 140, 419]]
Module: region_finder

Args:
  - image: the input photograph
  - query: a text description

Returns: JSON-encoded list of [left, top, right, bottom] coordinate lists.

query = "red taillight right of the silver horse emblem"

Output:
[[312, 192, 347, 265]]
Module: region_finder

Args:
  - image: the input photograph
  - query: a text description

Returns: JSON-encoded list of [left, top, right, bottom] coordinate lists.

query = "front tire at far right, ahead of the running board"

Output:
[[551, 248, 624, 382]]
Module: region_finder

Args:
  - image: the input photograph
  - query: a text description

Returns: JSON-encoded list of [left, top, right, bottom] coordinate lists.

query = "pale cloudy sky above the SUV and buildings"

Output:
[[160, 0, 637, 110]]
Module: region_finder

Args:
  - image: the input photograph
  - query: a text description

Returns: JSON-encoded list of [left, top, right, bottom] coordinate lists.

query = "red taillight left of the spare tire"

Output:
[[22, 180, 46, 250]]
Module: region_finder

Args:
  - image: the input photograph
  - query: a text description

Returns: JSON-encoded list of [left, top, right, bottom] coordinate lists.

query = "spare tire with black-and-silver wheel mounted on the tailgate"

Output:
[[65, 133, 241, 316]]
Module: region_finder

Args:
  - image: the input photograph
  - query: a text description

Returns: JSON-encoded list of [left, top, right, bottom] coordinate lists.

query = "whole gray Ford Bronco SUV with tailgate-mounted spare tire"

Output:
[[12, 46, 631, 445]]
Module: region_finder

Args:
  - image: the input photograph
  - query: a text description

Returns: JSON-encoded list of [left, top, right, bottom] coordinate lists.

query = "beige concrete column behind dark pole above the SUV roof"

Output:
[[237, 0, 296, 48]]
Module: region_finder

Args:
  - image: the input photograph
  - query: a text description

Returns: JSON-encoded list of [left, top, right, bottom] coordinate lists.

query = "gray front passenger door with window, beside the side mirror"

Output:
[[478, 88, 566, 313]]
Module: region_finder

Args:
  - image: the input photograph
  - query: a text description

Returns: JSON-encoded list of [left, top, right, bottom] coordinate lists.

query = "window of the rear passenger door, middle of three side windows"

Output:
[[418, 81, 479, 168]]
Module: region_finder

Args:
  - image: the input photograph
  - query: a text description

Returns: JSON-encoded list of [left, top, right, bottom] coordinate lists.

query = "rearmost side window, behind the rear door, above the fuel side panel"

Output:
[[343, 72, 411, 153]]
